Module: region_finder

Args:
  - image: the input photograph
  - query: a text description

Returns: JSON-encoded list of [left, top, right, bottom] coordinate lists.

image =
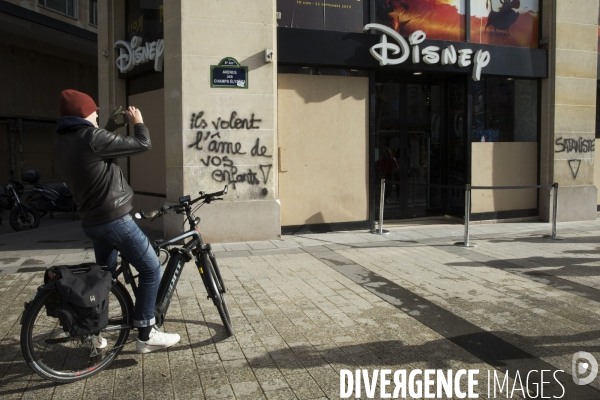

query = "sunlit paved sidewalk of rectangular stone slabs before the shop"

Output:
[[0, 220, 600, 400]]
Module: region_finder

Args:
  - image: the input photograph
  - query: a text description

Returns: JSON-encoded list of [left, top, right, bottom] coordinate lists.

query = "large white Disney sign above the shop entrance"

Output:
[[363, 24, 491, 81]]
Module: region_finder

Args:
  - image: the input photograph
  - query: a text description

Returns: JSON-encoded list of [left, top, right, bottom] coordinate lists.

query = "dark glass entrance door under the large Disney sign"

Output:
[[374, 75, 467, 219]]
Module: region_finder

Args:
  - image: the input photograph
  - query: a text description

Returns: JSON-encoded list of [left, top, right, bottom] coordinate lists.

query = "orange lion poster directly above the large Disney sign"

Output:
[[374, 0, 465, 42]]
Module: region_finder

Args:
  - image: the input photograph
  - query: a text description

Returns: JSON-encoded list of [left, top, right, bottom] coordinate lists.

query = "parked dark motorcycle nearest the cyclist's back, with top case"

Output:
[[21, 169, 76, 218]]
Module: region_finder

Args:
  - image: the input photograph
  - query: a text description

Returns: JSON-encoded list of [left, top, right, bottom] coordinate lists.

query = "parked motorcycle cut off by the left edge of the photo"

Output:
[[0, 173, 40, 231]]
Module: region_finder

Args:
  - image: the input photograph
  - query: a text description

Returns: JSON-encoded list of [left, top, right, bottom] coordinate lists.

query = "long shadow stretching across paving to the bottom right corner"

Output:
[[248, 330, 600, 400]]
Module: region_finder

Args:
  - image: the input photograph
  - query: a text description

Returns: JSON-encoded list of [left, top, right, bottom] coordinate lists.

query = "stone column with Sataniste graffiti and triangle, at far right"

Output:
[[539, 0, 599, 221]]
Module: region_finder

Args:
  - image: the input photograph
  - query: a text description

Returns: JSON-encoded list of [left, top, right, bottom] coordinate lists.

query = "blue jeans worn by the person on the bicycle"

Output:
[[83, 214, 161, 328]]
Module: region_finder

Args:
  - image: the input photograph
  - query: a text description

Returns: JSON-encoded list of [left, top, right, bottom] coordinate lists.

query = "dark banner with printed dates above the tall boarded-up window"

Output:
[[277, 0, 366, 32]]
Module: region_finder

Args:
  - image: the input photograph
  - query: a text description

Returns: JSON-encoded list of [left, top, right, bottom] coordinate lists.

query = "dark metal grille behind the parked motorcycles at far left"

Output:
[[0, 119, 60, 182]]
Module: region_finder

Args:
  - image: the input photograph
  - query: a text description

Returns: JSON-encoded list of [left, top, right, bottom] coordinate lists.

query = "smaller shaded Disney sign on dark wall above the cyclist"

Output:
[[115, 36, 165, 74]]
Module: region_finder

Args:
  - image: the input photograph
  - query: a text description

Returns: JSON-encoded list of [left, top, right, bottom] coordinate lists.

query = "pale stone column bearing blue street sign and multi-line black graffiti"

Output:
[[164, 0, 281, 242]]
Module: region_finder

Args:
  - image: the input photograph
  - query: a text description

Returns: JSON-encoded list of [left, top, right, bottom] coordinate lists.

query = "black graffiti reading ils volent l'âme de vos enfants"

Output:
[[188, 111, 273, 195]]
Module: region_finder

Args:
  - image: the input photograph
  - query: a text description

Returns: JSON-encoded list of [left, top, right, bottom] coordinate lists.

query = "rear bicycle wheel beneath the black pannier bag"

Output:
[[21, 283, 133, 383]]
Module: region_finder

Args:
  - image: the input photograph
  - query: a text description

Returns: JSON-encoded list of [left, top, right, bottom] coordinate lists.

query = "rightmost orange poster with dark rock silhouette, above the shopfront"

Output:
[[471, 0, 539, 48]]
